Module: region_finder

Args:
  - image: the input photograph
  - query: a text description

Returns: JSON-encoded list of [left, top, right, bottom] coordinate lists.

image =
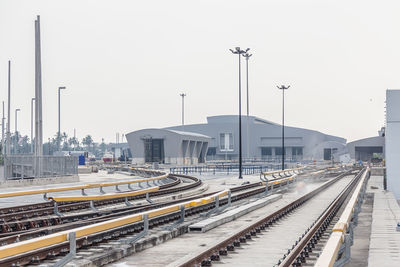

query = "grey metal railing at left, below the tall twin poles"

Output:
[[4, 155, 78, 179]]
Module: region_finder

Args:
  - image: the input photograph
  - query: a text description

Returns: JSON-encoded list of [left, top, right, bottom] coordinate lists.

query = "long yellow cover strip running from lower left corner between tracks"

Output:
[[0, 190, 230, 259]]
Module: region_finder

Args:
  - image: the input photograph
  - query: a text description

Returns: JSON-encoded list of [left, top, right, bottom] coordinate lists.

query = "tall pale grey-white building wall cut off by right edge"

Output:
[[385, 90, 400, 199]]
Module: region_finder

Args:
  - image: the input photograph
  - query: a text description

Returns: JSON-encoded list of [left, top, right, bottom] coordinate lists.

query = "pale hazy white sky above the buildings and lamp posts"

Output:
[[0, 0, 400, 142]]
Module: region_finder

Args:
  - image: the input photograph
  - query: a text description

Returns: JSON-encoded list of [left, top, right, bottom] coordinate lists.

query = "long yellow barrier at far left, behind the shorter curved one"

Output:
[[0, 174, 168, 198]]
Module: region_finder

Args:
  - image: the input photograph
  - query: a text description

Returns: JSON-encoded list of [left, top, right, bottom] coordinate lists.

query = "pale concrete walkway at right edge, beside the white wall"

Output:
[[368, 176, 400, 267]]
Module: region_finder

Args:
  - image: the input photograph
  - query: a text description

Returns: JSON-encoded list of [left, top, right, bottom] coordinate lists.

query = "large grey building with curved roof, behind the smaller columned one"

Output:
[[162, 115, 346, 161]]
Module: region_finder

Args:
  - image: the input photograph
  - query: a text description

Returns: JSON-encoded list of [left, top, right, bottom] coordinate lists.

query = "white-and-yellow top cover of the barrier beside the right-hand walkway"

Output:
[[314, 168, 369, 267]]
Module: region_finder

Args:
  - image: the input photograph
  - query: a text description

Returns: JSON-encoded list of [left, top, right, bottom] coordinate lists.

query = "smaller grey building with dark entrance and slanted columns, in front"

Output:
[[125, 129, 211, 165]]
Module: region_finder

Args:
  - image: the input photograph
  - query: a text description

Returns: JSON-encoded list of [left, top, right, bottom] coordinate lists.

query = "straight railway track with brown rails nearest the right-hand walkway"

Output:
[[177, 170, 365, 267]]
